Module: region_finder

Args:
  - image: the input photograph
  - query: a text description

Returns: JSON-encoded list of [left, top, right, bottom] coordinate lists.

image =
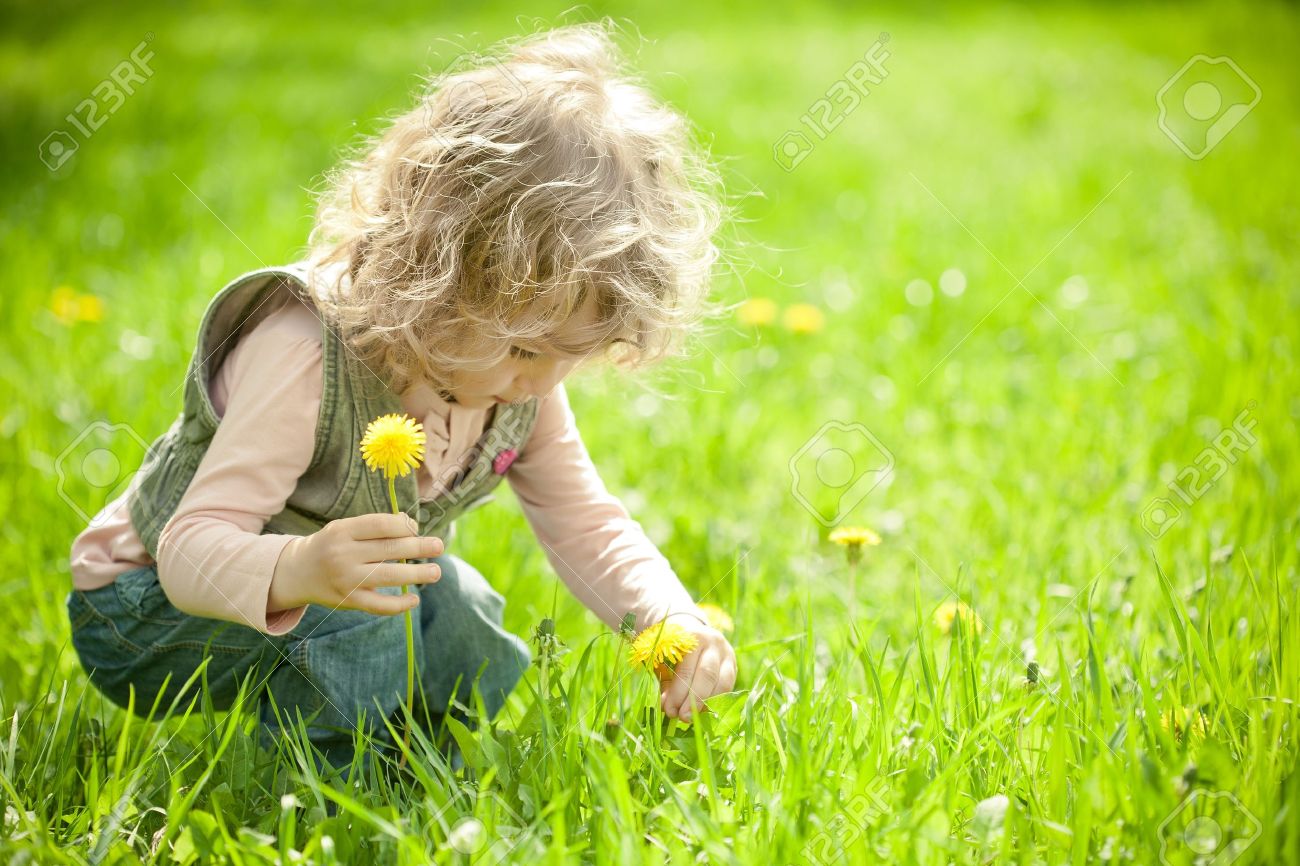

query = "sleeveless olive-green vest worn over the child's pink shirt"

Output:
[[129, 263, 538, 559]]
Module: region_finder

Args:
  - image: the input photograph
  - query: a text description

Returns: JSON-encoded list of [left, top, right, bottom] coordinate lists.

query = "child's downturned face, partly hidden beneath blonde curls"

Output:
[[436, 291, 597, 408]]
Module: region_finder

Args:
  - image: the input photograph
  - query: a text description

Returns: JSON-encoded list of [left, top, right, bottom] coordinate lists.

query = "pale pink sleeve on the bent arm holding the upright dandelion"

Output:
[[157, 303, 322, 635]]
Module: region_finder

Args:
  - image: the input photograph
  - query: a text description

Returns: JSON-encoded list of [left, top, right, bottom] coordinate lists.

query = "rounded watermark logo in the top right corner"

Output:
[[1156, 55, 1260, 160]]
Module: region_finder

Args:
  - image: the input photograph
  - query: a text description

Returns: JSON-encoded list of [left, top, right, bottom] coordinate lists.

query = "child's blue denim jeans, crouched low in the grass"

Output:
[[68, 554, 530, 767]]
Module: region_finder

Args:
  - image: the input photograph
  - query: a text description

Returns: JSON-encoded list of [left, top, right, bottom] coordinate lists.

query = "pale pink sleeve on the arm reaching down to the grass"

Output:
[[506, 384, 703, 631]]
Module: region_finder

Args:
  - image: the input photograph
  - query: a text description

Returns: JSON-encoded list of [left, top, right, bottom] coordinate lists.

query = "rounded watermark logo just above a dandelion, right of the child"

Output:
[[789, 421, 894, 527]]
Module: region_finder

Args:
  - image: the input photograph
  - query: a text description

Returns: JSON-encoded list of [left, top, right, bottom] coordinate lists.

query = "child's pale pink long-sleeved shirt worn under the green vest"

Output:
[[72, 296, 699, 635]]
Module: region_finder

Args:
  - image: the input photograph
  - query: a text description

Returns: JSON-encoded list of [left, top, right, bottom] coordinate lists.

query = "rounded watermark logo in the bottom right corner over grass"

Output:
[[1160, 789, 1262, 866]]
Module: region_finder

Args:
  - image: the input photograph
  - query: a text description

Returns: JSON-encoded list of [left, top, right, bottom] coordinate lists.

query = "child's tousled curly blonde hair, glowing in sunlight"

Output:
[[308, 23, 724, 387]]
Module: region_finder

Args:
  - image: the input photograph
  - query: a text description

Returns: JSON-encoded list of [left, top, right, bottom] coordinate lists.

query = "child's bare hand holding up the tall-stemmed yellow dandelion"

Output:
[[269, 514, 443, 616]]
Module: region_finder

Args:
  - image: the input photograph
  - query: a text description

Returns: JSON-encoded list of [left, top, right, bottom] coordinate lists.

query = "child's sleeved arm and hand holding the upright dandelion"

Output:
[[157, 304, 442, 635]]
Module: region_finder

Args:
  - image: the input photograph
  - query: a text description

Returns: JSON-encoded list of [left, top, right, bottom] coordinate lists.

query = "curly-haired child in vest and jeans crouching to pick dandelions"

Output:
[[68, 25, 736, 763]]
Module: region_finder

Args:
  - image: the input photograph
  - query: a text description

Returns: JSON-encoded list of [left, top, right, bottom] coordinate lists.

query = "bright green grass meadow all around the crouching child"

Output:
[[0, 3, 1300, 863]]
